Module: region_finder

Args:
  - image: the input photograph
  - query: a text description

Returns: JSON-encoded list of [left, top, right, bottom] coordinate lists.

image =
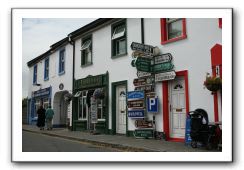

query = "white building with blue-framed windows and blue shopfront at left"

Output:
[[27, 38, 73, 127]]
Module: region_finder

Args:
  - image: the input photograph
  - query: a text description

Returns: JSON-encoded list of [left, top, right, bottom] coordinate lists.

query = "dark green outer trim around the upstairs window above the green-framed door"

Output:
[[111, 19, 128, 59]]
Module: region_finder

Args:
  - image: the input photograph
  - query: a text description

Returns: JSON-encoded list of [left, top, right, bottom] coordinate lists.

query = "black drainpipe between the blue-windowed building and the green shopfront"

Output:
[[68, 34, 75, 131]]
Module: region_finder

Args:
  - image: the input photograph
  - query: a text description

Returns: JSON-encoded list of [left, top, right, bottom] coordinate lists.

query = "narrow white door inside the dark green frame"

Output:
[[116, 85, 126, 134]]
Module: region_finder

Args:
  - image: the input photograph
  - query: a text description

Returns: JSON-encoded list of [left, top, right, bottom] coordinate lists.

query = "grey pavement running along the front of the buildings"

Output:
[[22, 125, 210, 152]]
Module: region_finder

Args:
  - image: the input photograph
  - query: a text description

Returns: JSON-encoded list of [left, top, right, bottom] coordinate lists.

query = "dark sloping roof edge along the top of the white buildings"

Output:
[[27, 18, 113, 67]]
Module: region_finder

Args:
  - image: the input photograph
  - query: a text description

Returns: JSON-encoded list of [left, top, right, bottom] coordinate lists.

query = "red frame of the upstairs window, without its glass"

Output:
[[160, 18, 187, 45]]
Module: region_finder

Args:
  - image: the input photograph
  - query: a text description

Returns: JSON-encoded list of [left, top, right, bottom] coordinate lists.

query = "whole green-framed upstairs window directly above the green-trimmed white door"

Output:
[[111, 20, 127, 57]]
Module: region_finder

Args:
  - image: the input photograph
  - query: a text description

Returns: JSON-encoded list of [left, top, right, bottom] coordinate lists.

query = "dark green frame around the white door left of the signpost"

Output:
[[111, 80, 128, 136]]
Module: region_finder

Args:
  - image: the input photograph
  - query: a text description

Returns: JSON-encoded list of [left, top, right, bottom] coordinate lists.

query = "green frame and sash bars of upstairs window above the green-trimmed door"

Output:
[[111, 19, 128, 59]]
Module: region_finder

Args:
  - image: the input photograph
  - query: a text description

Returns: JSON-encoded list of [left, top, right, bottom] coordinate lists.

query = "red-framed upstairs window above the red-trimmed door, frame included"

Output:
[[161, 18, 187, 44]]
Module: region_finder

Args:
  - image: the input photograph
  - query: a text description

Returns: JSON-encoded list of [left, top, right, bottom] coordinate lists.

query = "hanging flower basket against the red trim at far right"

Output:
[[204, 73, 222, 92]]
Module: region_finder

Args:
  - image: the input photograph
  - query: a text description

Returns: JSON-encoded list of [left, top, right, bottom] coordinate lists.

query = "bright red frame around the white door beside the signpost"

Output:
[[162, 70, 189, 142]]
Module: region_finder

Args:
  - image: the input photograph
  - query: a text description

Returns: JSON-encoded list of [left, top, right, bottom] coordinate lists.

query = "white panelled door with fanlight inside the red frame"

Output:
[[169, 76, 186, 138]]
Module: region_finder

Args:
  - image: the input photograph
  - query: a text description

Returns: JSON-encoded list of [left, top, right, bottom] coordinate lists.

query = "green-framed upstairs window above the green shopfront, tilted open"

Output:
[[81, 37, 92, 66]]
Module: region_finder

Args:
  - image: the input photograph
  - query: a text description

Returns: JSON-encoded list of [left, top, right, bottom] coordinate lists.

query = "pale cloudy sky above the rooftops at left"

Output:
[[22, 18, 95, 97]]
